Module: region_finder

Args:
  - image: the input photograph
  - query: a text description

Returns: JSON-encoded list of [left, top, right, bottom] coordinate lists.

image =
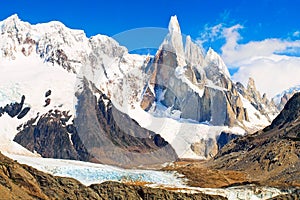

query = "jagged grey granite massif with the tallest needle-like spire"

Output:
[[142, 17, 272, 128]]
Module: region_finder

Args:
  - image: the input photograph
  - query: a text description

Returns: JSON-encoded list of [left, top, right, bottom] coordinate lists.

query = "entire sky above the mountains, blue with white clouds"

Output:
[[0, 0, 300, 96]]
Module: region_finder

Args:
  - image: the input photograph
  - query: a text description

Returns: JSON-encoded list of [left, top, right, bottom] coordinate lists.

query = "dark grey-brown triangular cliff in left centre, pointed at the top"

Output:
[[74, 80, 177, 167]]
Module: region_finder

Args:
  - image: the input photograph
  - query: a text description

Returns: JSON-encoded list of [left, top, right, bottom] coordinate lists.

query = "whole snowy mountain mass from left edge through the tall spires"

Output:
[[0, 15, 275, 166]]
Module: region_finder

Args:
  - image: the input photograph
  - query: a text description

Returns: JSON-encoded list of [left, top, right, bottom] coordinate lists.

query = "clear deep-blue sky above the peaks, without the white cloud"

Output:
[[0, 0, 300, 41]]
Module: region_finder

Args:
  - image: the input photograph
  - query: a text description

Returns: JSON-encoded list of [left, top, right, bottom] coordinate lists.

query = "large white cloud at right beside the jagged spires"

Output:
[[221, 24, 300, 97]]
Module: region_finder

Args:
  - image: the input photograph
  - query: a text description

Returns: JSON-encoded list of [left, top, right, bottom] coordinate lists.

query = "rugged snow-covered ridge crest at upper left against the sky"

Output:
[[0, 15, 127, 73]]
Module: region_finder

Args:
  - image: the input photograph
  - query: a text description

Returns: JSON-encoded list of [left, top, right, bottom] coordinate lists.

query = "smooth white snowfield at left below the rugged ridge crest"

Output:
[[0, 54, 77, 155]]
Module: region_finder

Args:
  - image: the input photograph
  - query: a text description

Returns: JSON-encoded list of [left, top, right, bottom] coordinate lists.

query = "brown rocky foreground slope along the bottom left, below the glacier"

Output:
[[0, 153, 225, 200]]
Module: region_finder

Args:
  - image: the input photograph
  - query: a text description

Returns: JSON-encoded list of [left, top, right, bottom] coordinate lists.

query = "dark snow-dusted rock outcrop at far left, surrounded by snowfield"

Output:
[[14, 110, 92, 161]]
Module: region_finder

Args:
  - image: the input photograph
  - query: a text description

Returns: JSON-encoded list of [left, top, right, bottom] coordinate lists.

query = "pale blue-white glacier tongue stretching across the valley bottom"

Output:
[[5, 153, 293, 200]]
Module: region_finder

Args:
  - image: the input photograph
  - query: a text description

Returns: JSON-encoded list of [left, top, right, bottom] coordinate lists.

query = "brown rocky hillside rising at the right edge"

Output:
[[213, 93, 300, 186]]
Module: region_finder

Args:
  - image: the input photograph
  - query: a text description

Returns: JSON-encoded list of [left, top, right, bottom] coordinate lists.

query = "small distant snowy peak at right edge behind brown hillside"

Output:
[[273, 85, 300, 110]]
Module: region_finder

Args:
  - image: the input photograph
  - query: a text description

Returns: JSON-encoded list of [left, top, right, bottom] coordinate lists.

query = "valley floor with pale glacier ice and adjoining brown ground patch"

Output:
[[6, 154, 293, 199]]
